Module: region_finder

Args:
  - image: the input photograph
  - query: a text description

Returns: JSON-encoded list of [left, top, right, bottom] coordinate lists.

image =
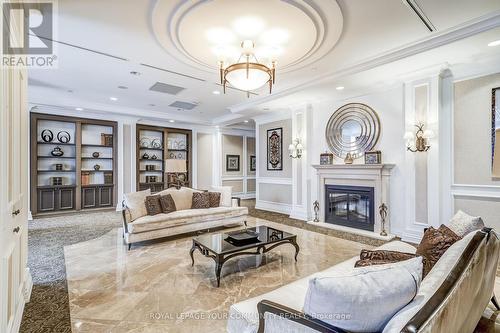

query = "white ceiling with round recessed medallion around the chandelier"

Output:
[[29, 0, 500, 126]]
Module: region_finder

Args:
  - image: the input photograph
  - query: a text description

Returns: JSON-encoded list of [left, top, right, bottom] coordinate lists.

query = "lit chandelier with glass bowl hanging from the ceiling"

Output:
[[219, 40, 276, 97]]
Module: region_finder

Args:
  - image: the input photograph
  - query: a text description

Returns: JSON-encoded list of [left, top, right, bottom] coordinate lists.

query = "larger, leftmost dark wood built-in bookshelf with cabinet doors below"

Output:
[[30, 113, 117, 216]]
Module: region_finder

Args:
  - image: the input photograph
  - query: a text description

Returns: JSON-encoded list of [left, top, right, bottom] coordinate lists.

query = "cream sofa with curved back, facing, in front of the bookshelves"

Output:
[[122, 186, 248, 249]]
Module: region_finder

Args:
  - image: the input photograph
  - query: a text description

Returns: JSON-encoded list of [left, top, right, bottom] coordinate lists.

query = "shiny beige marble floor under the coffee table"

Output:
[[64, 217, 500, 333]]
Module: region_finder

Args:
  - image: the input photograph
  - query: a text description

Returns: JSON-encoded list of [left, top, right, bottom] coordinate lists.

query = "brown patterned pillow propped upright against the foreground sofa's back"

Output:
[[416, 224, 461, 277]]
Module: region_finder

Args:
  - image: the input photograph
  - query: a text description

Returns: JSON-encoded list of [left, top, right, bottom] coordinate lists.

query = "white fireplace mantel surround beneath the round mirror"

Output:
[[312, 164, 395, 234]]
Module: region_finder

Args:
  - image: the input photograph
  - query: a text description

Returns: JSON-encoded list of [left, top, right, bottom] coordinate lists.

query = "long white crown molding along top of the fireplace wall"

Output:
[[229, 10, 500, 113]]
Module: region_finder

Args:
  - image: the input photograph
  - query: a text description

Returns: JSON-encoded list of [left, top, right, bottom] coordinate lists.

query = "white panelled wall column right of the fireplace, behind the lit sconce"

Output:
[[402, 70, 453, 242]]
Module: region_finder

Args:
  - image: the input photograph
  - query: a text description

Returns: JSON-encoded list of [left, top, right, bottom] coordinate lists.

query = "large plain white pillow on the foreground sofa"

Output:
[[304, 257, 422, 332]]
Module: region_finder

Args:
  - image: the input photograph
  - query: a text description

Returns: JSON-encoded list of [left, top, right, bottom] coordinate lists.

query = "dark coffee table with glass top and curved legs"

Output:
[[189, 225, 300, 287]]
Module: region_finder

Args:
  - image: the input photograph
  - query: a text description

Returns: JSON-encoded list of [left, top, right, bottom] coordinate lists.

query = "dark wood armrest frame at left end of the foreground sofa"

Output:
[[257, 300, 347, 333]]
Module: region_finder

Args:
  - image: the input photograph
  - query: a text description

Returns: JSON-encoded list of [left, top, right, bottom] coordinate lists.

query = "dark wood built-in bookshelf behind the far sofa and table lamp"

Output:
[[136, 124, 192, 192]]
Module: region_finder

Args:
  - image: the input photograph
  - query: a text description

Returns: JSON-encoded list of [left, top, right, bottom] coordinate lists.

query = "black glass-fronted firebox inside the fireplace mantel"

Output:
[[325, 185, 375, 231]]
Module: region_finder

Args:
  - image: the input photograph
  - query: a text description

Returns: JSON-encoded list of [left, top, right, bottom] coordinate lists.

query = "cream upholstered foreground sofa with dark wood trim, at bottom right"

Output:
[[227, 228, 500, 333]]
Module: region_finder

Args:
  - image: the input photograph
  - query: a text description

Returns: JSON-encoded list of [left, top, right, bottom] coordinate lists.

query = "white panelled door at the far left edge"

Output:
[[0, 1, 31, 333]]
